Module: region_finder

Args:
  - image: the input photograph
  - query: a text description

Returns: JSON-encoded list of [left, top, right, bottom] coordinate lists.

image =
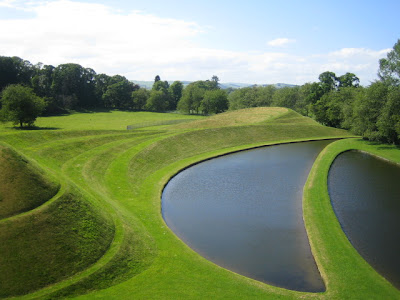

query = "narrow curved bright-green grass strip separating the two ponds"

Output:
[[303, 139, 400, 299]]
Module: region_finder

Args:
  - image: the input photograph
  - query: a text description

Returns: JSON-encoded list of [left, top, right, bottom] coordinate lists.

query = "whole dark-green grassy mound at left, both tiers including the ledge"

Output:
[[0, 146, 114, 298]]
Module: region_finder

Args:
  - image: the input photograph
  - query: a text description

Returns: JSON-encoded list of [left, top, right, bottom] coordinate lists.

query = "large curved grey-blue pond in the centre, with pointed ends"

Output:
[[162, 141, 331, 292]]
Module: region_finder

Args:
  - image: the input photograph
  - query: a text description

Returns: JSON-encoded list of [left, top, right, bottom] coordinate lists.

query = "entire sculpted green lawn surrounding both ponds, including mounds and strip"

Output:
[[0, 108, 400, 299]]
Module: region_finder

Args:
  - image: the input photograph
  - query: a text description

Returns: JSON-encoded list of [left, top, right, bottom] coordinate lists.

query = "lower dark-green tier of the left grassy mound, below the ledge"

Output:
[[0, 183, 114, 298]]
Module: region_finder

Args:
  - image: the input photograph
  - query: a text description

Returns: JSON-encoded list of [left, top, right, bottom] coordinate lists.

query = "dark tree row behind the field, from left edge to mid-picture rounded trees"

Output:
[[0, 56, 228, 114]]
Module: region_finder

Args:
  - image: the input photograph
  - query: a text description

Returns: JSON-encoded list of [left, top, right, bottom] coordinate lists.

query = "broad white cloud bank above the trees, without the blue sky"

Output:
[[0, 0, 389, 84]]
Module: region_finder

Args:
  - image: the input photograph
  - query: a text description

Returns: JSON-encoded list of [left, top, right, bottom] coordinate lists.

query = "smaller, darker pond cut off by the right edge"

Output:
[[328, 151, 400, 288]]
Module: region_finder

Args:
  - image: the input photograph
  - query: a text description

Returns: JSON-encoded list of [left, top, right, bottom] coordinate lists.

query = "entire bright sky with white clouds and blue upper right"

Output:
[[0, 0, 400, 86]]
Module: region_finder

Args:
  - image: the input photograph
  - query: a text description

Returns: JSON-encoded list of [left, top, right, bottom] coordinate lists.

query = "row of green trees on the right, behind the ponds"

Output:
[[228, 40, 400, 144]]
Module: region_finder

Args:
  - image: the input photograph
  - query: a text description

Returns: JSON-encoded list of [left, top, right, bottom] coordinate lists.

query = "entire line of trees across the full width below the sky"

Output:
[[0, 40, 400, 144]]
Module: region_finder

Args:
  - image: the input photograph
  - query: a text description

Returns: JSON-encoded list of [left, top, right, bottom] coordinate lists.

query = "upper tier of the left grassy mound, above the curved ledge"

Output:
[[0, 145, 59, 219]]
